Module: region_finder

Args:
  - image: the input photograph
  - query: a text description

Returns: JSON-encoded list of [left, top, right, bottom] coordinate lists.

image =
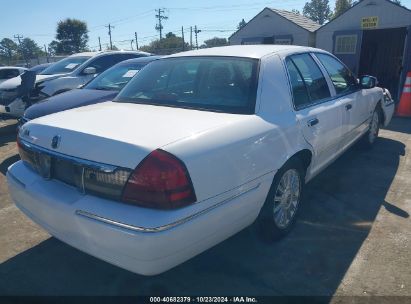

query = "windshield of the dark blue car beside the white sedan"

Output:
[[84, 64, 145, 91]]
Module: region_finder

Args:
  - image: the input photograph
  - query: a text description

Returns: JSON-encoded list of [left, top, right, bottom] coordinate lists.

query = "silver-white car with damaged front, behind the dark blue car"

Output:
[[0, 51, 151, 117]]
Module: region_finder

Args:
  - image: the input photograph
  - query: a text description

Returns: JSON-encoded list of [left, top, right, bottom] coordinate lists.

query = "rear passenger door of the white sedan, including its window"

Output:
[[286, 53, 342, 174]]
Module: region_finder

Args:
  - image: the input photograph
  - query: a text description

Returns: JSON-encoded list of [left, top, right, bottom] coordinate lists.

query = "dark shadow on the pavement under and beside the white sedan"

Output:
[[0, 138, 409, 296]]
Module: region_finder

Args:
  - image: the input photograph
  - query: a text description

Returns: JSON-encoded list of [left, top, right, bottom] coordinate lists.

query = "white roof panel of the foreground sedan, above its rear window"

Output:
[[167, 44, 319, 59]]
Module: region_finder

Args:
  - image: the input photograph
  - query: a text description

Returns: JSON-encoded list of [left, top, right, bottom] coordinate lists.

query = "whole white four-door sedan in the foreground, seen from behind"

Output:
[[7, 45, 393, 275]]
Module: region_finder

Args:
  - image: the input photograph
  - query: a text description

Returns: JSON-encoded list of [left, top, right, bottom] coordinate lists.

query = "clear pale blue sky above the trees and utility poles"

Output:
[[0, 0, 411, 49]]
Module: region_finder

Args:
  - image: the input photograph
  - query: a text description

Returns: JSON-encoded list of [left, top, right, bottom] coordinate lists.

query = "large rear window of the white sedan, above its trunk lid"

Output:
[[115, 56, 258, 114]]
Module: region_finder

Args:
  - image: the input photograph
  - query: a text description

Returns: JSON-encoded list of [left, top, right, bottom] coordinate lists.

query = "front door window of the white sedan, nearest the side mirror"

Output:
[[316, 53, 358, 95]]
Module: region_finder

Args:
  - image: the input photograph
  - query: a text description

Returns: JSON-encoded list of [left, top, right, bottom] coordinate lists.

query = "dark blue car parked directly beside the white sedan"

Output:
[[20, 56, 161, 125]]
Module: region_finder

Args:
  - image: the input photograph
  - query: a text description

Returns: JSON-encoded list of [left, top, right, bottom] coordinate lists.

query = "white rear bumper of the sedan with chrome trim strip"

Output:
[[7, 161, 272, 275]]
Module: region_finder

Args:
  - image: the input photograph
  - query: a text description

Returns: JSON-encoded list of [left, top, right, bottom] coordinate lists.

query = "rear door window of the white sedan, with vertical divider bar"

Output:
[[286, 54, 331, 109]]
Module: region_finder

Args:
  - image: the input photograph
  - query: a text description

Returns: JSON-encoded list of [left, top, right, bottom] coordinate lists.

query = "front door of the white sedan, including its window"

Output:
[[315, 53, 370, 150]]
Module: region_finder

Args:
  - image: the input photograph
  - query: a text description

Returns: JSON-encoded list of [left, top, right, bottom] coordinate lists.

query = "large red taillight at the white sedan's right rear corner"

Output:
[[122, 150, 196, 209]]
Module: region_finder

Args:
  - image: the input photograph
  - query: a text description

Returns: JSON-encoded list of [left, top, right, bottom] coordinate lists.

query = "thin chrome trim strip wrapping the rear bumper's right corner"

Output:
[[75, 183, 260, 233]]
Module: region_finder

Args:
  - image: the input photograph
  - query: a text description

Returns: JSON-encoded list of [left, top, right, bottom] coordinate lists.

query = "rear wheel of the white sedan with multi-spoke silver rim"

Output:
[[257, 159, 305, 242]]
